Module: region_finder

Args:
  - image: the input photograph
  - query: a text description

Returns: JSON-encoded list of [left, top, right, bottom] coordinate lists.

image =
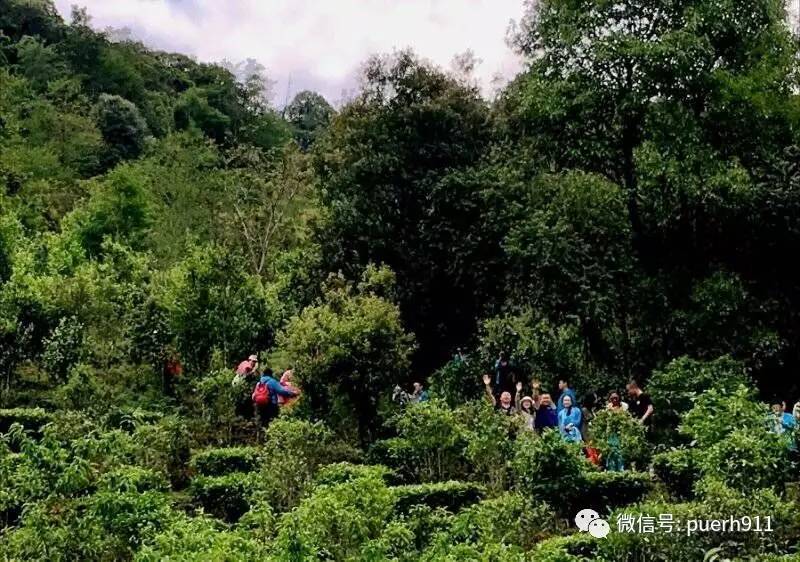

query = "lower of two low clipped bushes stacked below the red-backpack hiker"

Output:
[[189, 472, 263, 522]]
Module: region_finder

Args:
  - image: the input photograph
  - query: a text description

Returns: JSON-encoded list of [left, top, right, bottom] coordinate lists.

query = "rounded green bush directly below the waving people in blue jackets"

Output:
[[512, 430, 589, 504]]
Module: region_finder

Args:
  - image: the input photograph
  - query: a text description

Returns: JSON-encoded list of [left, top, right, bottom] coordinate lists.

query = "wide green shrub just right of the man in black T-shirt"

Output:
[[648, 357, 749, 427]]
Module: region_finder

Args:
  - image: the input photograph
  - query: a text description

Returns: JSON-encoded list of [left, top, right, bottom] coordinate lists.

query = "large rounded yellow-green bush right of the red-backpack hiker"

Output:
[[278, 268, 415, 443]]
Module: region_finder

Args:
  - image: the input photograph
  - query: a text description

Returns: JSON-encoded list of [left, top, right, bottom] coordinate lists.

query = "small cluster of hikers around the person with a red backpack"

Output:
[[232, 355, 300, 430]]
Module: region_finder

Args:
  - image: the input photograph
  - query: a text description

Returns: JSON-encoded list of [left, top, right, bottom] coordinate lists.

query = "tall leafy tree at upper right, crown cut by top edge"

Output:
[[506, 0, 794, 247]]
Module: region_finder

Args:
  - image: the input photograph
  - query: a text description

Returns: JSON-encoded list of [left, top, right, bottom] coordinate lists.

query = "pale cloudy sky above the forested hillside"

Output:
[[50, 0, 523, 106]]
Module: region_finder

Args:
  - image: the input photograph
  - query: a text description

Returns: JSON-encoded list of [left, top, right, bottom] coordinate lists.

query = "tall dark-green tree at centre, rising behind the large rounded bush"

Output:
[[316, 52, 499, 366]]
